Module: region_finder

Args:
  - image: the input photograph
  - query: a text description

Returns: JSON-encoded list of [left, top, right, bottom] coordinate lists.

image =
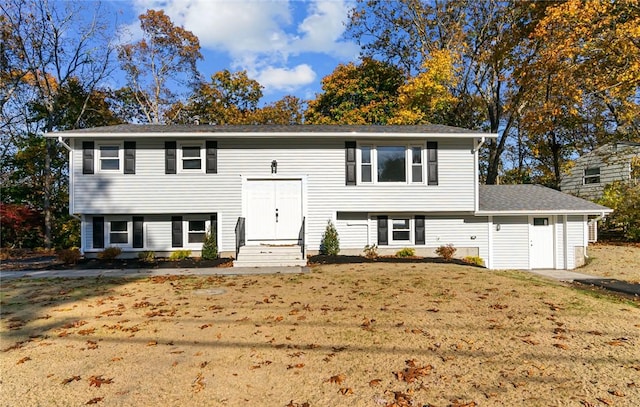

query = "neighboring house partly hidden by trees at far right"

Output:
[[560, 142, 640, 200]]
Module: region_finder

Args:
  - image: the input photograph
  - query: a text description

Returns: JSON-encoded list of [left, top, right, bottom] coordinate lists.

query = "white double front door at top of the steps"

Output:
[[245, 179, 302, 243]]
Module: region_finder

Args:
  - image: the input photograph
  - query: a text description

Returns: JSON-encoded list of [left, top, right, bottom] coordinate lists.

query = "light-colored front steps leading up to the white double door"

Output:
[[233, 245, 307, 267]]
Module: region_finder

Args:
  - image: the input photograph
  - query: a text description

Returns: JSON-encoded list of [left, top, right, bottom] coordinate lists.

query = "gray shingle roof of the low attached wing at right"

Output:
[[479, 184, 611, 214]]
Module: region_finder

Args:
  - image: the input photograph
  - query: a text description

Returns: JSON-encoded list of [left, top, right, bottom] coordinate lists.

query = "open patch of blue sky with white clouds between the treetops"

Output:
[[101, 0, 359, 103]]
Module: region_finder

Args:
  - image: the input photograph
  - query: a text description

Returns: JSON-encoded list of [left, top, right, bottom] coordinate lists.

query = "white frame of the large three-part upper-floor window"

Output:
[[356, 141, 427, 185]]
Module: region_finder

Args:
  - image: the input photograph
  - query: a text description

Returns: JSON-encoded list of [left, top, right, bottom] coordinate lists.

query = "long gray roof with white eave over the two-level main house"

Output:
[[49, 124, 497, 137]]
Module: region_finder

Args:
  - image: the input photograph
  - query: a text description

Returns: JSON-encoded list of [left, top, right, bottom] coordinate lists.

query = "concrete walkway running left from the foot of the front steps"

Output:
[[0, 267, 310, 280]]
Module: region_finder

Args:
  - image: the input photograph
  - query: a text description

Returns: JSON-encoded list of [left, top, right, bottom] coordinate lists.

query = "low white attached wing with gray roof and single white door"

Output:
[[476, 185, 611, 269]]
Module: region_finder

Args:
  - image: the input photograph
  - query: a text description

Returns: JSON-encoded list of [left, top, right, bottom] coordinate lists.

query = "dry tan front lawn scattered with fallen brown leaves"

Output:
[[0, 264, 640, 406]]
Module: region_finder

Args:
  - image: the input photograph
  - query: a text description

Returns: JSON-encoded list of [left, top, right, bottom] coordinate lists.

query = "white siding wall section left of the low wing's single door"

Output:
[[492, 216, 529, 269]]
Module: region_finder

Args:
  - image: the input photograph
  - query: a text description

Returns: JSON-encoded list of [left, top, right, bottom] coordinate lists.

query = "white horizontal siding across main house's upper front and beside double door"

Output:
[[72, 135, 475, 255]]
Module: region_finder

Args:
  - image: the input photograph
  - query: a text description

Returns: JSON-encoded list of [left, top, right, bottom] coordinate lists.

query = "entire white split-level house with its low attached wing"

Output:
[[50, 125, 610, 269]]
